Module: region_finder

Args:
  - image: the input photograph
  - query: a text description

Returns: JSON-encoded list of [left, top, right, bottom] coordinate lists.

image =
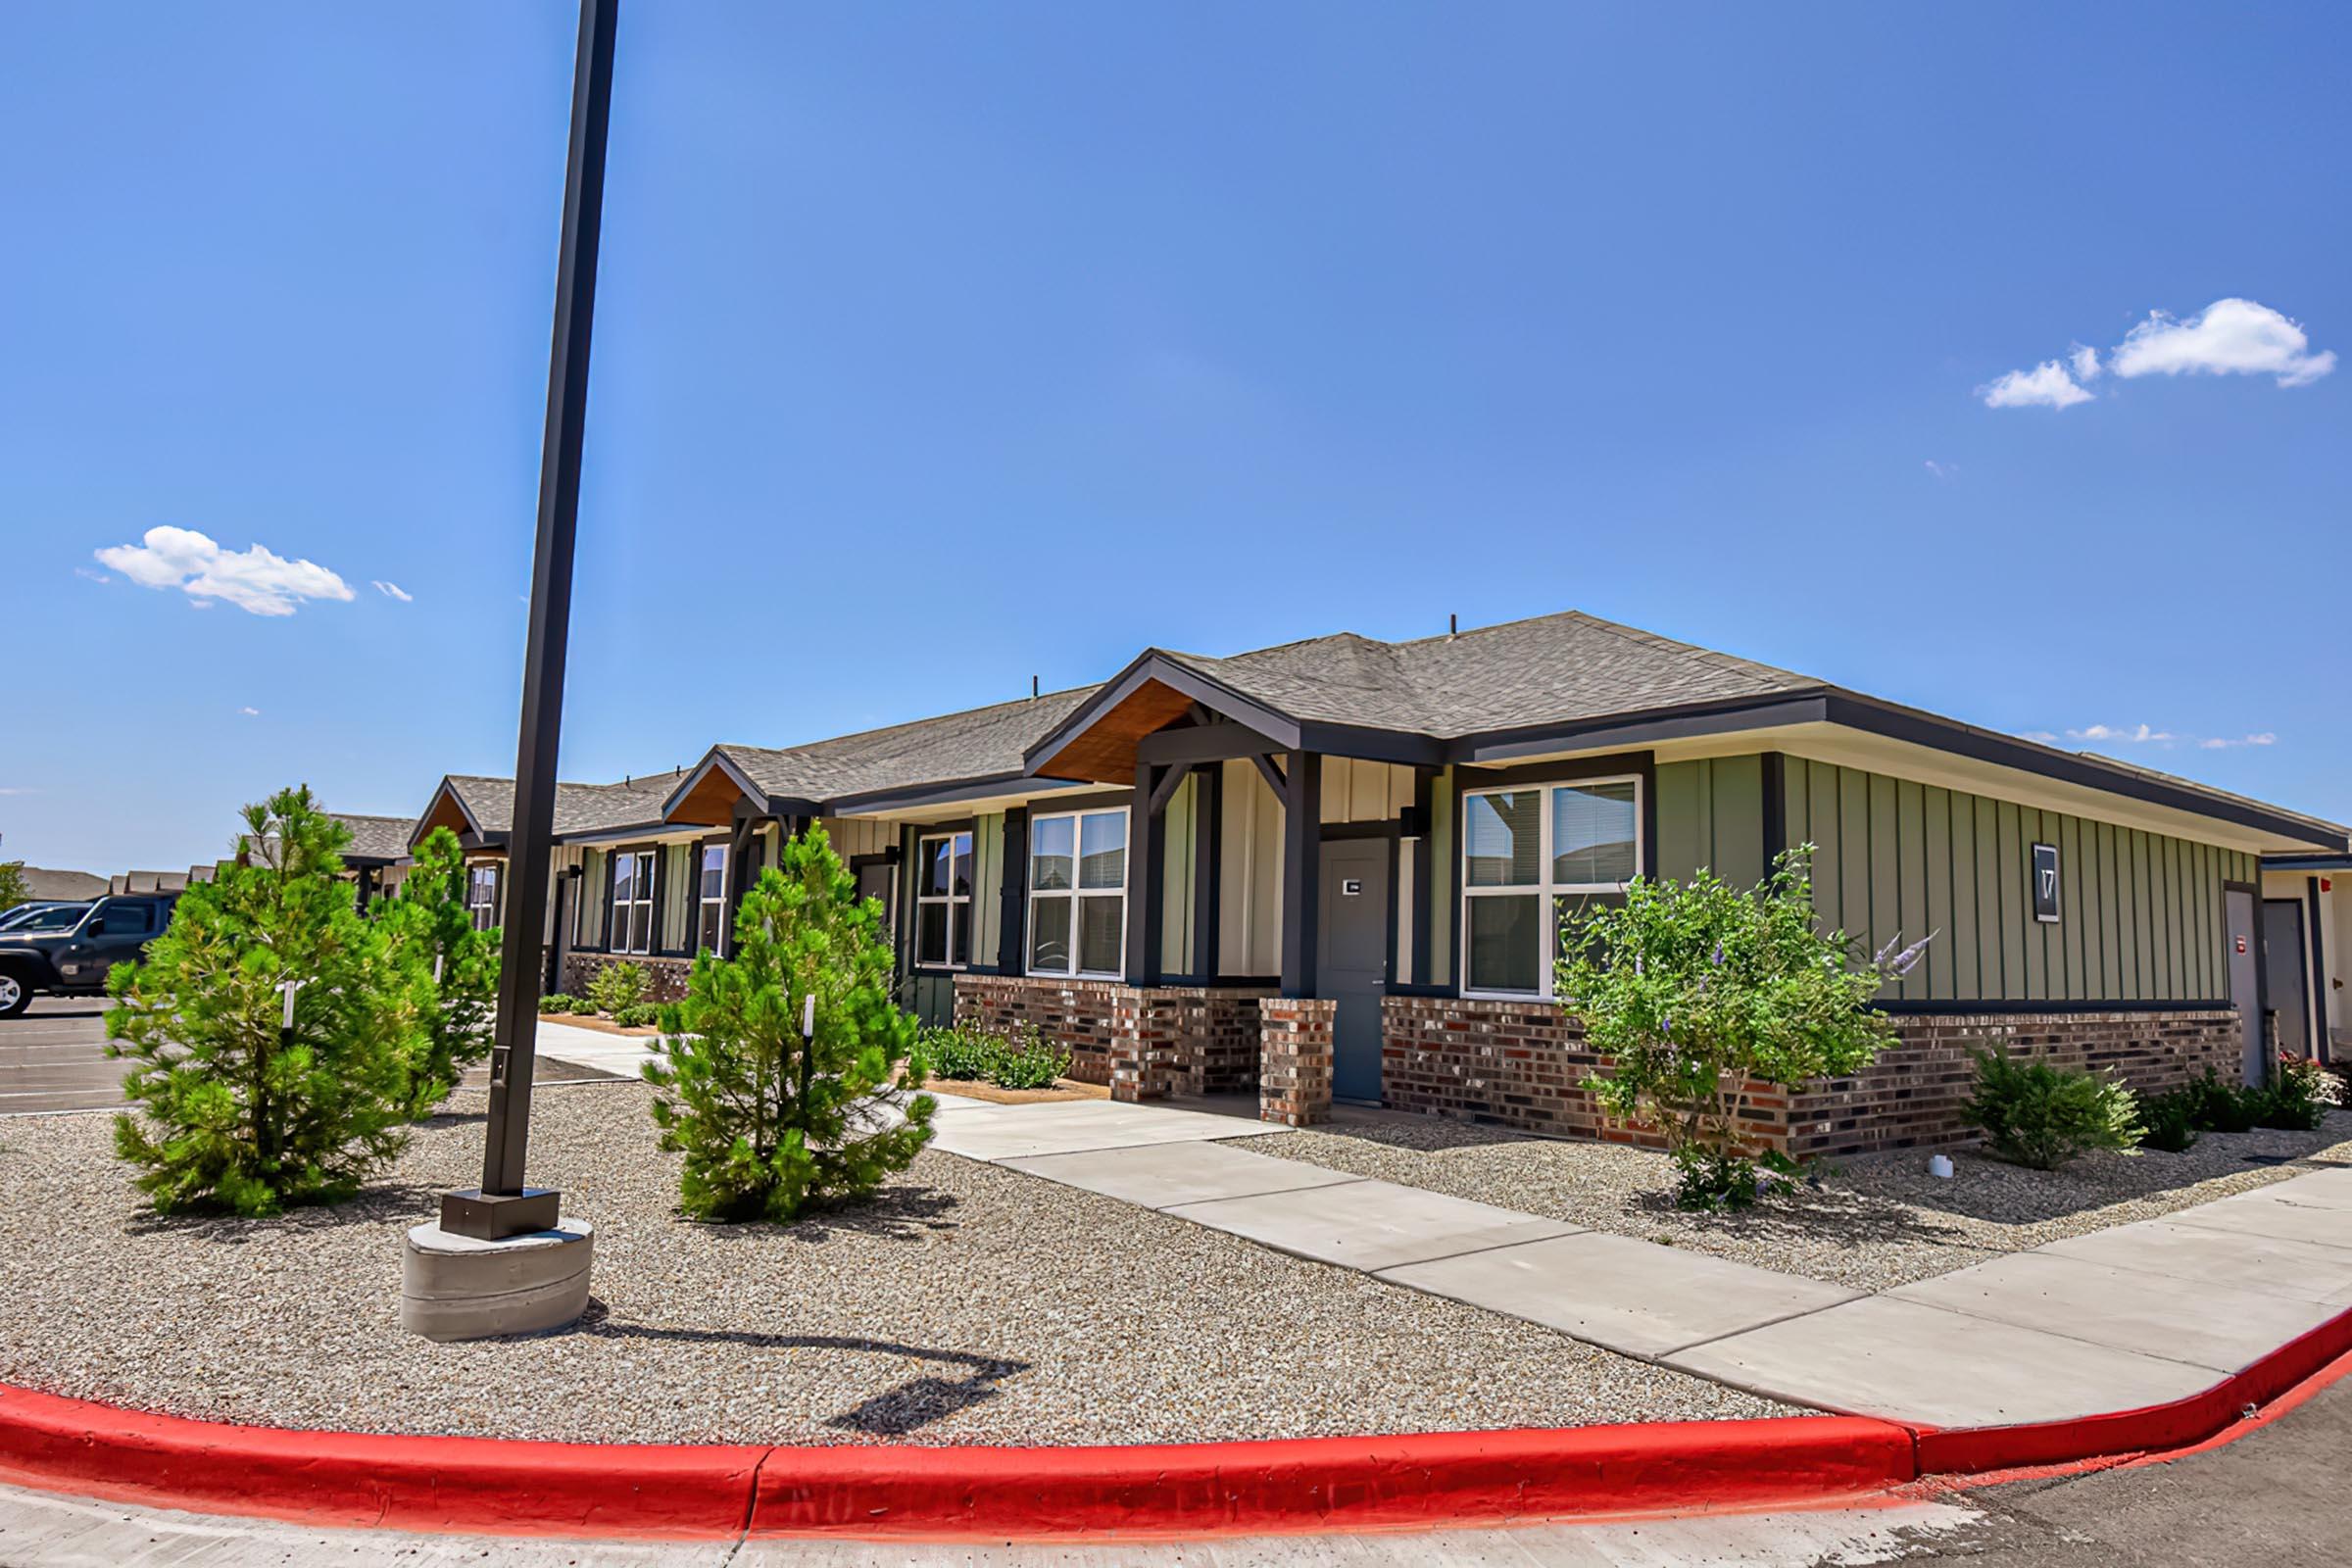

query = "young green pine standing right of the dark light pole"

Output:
[[645, 827, 936, 1220]]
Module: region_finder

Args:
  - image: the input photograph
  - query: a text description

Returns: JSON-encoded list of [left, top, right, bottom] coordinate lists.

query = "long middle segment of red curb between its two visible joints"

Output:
[[751, 1415, 1915, 1540]]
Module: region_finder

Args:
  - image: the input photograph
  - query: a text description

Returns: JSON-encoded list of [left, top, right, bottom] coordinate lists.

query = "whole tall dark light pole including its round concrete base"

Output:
[[400, 0, 621, 1338]]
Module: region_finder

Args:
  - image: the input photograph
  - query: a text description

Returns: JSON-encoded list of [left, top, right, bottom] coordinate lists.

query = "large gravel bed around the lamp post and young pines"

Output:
[[0, 1084, 1789, 1444]]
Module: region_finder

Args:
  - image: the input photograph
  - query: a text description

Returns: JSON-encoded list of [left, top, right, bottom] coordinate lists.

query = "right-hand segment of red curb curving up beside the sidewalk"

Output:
[[1917, 1312, 2352, 1476]]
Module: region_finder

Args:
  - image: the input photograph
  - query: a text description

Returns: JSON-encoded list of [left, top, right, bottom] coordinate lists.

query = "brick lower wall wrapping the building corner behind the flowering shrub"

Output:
[[1381, 997, 2239, 1159]]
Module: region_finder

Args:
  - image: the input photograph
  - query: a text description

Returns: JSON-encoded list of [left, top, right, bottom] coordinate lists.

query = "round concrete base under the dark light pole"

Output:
[[400, 1220, 595, 1340]]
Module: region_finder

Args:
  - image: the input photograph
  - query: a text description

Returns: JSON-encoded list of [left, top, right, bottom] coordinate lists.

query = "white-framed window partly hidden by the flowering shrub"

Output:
[[1463, 778, 1642, 997]]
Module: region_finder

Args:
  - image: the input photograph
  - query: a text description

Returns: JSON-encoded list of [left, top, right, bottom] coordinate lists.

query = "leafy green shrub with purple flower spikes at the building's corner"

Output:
[[1552, 844, 1927, 1208]]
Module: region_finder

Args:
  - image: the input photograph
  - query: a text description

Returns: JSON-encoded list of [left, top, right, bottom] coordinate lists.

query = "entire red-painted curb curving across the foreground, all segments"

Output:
[[0, 1312, 2352, 1540]]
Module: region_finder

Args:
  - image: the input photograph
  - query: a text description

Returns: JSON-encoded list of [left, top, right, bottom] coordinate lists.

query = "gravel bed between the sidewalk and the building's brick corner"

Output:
[[1240, 1109, 2352, 1291]]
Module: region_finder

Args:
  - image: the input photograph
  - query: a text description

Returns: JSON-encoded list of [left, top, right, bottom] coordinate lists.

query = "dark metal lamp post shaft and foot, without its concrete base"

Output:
[[442, 0, 621, 1239]]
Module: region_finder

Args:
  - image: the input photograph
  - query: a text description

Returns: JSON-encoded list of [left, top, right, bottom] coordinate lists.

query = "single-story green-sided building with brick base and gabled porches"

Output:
[[418, 613, 2352, 1154]]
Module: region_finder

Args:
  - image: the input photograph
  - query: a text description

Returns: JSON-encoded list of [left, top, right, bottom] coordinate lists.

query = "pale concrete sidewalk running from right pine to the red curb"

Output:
[[934, 1101, 2352, 1427]]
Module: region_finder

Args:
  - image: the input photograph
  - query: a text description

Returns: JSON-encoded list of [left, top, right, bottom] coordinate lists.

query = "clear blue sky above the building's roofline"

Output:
[[0, 0, 2352, 870]]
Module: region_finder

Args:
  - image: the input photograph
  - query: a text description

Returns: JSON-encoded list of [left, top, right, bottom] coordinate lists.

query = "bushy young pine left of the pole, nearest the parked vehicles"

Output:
[[106, 788, 433, 1215]]
